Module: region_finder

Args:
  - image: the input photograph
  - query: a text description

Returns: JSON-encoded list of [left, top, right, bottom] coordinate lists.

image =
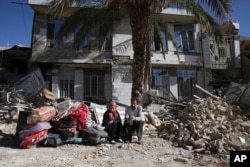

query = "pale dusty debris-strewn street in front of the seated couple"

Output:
[[0, 120, 229, 167]]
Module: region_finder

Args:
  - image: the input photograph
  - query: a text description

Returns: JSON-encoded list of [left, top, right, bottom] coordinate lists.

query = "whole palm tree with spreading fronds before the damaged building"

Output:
[[49, 0, 231, 101]]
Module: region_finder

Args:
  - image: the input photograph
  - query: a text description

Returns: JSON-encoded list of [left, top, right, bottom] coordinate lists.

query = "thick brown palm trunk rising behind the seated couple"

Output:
[[130, 8, 150, 103]]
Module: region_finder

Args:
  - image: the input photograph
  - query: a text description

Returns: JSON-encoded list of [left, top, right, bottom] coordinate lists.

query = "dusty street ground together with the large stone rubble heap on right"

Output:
[[0, 97, 250, 167]]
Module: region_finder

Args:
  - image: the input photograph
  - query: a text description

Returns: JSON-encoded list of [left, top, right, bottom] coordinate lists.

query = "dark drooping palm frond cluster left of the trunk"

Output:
[[57, 8, 121, 48]]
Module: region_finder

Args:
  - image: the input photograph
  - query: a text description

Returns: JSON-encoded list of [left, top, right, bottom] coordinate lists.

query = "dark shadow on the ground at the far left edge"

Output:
[[0, 132, 21, 149]]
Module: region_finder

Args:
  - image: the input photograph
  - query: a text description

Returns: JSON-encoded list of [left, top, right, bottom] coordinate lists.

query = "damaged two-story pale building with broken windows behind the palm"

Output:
[[29, 0, 242, 110]]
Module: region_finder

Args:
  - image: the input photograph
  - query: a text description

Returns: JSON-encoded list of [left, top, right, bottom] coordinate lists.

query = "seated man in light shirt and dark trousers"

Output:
[[124, 98, 144, 144]]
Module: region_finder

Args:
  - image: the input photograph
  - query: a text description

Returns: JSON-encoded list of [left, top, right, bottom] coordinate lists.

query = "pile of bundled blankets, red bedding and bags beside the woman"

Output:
[[18, 99, 104, 148]]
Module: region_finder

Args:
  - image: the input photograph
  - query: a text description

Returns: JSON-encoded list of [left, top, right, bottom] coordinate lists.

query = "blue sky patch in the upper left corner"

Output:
[[0, 0, 34, 47]]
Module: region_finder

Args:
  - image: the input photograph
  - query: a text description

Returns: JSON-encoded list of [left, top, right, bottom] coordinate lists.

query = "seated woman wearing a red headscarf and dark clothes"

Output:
[[102, 101, 123, 144]]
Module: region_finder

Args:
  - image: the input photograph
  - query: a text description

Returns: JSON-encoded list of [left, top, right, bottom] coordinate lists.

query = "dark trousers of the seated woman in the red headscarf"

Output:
[[105, 121, 122, 141]]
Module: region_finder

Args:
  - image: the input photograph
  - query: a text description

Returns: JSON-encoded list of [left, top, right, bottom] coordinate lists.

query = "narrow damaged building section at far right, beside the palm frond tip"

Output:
[[203, 20, 242, 92]]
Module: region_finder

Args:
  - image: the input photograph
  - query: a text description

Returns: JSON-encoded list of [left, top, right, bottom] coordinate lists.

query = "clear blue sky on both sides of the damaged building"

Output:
[[0, 0, 250, 47]]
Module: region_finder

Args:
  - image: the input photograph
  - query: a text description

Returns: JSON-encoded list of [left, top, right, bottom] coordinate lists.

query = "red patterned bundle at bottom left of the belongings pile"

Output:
[[19, 129, 48, 148]]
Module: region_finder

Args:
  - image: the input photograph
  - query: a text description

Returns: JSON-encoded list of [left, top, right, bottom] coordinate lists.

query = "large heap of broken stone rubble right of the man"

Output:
[[155, 97, 250, 153]]
